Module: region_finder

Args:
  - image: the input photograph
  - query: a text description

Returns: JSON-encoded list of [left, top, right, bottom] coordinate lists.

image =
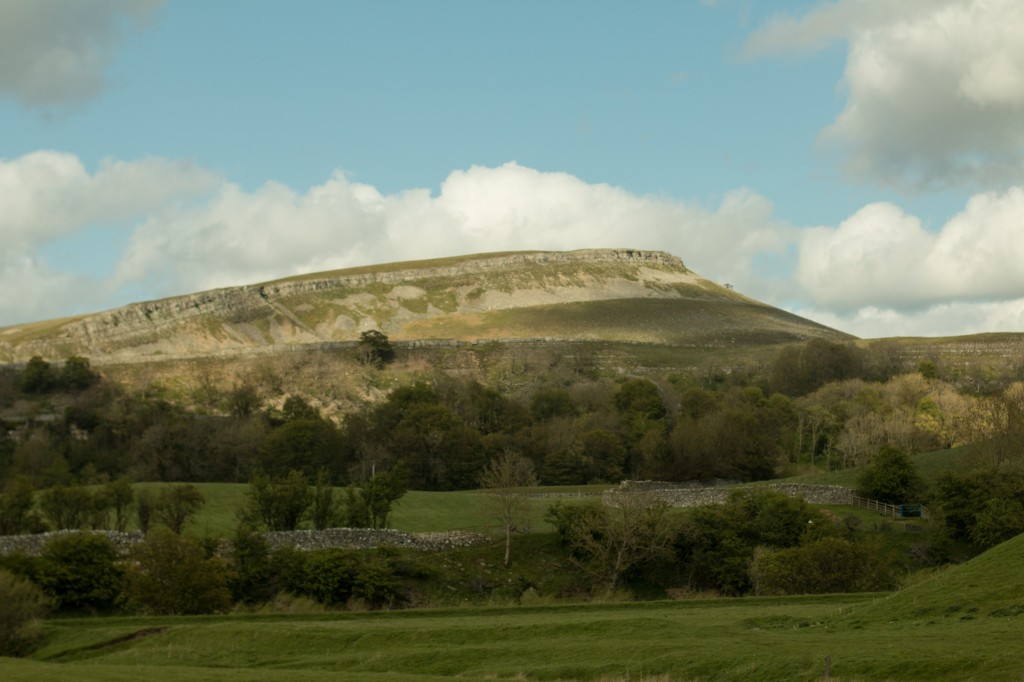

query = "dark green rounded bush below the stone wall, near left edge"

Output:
[[37, 532, 124, 611]]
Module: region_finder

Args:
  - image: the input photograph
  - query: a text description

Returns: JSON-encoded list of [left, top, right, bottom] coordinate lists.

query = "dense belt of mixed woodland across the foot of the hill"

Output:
[[6, 337, 1024, 489]]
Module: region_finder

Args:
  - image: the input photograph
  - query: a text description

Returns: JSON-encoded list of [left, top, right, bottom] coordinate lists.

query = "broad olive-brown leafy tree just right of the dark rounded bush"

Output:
[[124, 528, 231, 615]]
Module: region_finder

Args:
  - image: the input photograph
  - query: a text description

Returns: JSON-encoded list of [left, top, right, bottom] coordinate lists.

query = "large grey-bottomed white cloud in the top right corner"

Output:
[[745, 0, 1024, 189]]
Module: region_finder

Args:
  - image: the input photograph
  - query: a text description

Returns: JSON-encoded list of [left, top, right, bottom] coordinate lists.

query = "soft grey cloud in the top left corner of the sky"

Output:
[[0, 0, 162, 106]]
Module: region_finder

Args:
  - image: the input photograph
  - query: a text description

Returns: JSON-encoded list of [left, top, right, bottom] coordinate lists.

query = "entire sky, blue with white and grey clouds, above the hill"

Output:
[[0, 0, 1024, 337]]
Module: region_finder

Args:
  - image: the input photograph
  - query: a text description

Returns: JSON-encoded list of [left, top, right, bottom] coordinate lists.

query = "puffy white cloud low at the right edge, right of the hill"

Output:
[[797, 187, 1024, 311]]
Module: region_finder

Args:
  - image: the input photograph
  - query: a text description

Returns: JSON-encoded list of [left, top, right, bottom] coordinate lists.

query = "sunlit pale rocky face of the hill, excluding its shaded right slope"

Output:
[[0, 249, 830, 364]]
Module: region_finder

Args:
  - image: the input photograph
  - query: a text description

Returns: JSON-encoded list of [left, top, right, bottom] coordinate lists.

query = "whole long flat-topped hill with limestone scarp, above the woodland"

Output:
[[0, 244, 850, 361]]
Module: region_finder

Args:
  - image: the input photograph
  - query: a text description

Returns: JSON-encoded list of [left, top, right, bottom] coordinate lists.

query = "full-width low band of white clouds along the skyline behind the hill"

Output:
[[8, 153, 1024, 337]]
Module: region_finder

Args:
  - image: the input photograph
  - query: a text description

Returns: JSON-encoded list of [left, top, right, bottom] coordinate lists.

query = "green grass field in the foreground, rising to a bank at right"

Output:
[[12, 537, 1024, 681]]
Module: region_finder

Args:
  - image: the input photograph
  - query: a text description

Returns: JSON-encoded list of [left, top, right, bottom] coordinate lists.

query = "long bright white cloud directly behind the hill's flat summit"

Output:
[[117, 163, 792, 301]]
